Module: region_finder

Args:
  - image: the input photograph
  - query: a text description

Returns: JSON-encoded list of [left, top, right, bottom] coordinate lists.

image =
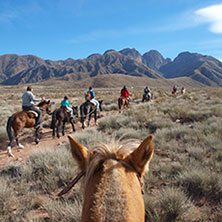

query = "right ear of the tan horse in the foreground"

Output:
[[126, 135, 154, 177]]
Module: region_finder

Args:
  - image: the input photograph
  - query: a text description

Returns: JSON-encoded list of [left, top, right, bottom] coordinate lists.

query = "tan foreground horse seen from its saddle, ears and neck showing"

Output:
[[68, 135, 154, 222]]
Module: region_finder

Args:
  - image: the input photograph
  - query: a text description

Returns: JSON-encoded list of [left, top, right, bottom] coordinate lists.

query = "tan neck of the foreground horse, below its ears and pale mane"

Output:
[[82, 160, 145, 222]]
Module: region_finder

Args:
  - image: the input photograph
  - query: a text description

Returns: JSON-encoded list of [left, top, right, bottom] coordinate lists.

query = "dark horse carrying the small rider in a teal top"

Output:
[[51, 106, 78, 138]]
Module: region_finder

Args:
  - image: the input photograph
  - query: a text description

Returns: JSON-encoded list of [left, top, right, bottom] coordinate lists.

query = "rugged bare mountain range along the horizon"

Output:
[[0, 48, 222, 86]]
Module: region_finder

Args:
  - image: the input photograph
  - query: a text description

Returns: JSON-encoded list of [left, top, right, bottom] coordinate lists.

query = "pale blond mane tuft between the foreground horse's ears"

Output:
[[85, 139, 139, 186]]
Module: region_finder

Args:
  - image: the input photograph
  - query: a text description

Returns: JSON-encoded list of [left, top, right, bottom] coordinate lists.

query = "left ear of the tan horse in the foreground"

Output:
[[68, 136, 88, 170]]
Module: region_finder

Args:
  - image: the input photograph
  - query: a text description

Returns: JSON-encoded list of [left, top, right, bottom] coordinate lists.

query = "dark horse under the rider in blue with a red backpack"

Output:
[[79, 100, 103, 129]]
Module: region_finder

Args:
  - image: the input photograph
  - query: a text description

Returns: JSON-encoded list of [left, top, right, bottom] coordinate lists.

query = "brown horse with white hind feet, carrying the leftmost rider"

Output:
[[6, 100, 51, 157]]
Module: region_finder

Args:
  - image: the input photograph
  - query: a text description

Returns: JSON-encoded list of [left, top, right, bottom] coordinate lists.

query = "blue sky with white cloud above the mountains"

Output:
[[0, 0, 222, 61]]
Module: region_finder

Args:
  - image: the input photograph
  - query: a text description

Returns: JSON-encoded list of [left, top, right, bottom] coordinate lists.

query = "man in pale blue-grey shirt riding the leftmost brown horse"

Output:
[[22, 86, 45, 129]]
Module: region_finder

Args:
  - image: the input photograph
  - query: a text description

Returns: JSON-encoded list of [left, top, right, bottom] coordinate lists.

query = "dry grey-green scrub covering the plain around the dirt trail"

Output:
[[0, 86, 222, 222]]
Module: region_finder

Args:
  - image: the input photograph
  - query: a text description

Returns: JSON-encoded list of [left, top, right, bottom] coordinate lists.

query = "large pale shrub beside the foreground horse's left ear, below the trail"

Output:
[[21, 146, 77, 192]]
